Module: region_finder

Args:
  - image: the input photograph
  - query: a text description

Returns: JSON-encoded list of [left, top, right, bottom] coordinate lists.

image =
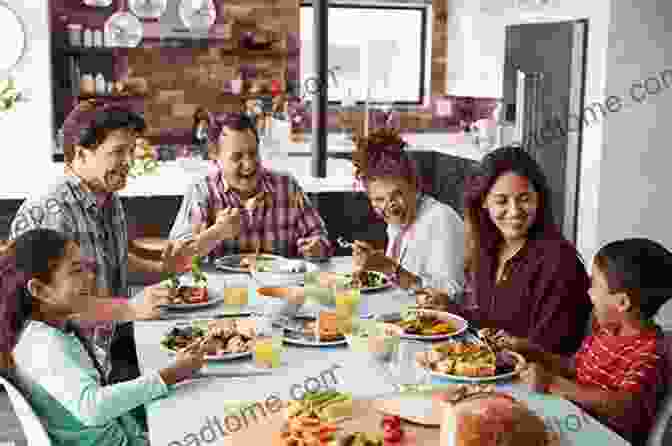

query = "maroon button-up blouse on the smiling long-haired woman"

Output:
[[460, 233, 592, 355]]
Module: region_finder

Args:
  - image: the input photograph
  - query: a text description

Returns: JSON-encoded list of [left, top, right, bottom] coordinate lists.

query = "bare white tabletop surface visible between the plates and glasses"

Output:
[[135, 257, 627, 446]]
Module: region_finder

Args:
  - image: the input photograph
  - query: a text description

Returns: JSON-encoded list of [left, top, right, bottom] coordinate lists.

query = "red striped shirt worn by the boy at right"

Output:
[[575, 322, 663, 444]]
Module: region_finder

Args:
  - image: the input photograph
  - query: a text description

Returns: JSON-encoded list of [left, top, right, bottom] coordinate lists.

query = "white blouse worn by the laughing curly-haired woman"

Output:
[[385, 194, 465, 295]]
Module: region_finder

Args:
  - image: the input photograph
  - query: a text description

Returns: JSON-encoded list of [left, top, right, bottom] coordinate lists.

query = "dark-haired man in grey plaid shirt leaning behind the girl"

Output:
[[10, 104, 193, 382]]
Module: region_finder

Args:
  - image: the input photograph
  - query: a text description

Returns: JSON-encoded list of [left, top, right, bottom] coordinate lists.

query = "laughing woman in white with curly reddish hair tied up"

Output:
[[353, 129, 464, 295]]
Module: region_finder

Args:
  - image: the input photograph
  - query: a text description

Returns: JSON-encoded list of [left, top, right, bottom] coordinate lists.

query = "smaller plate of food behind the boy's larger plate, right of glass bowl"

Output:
[[378, 309, 469, 341]]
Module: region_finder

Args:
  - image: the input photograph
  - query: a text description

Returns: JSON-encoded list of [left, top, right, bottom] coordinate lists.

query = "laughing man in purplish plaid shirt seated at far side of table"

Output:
[[171, 110, 333, 258]]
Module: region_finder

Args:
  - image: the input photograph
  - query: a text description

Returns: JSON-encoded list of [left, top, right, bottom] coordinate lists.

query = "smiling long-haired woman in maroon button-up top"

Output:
[[418, 147, 591, 355]]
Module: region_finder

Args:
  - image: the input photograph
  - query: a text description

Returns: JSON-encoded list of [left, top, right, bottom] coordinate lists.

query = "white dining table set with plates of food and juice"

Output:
[[133, 257, 628, 446]]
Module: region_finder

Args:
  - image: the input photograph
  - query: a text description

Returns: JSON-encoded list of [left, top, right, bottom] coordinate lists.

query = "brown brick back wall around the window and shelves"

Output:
[[50, 0, 495, 144]]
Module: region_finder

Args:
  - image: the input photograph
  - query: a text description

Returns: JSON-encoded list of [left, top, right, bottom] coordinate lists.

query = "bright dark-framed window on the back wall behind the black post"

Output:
[[300, 3, 428, 105]]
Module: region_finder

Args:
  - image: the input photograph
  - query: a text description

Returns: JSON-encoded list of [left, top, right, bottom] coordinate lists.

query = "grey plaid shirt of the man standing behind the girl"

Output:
[[10, 175, 128, 371]]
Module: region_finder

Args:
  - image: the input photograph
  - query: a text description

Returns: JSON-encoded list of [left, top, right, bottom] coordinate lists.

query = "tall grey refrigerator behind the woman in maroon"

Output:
[[502, 20, 588, 243]]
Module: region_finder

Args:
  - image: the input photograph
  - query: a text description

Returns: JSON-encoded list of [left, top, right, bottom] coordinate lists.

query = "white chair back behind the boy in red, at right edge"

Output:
[[646, 330, 672, 446]]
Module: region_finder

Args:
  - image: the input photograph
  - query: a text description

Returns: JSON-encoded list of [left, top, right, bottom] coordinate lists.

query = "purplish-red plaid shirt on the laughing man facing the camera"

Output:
[[171, 161, 333, 257]]
